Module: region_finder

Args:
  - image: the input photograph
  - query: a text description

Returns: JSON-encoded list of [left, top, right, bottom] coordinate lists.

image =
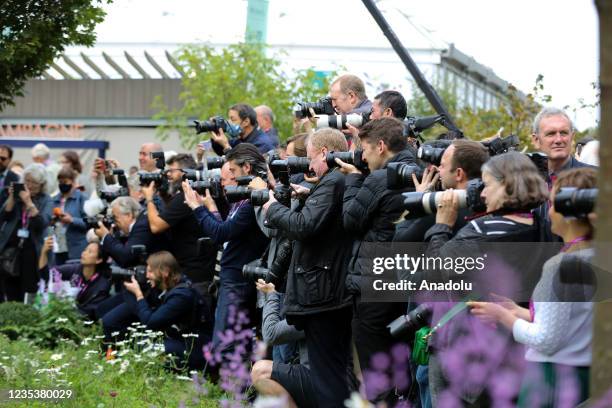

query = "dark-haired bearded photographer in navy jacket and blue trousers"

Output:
[[183, 143, 268, 346]]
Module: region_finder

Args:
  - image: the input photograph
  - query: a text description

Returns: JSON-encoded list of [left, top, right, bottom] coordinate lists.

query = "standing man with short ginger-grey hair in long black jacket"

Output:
[[263, 129, 351, 407]]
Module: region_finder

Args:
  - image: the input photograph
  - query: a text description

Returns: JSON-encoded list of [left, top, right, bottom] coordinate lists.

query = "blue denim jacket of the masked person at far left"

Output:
[[49, 190, 87, 259]]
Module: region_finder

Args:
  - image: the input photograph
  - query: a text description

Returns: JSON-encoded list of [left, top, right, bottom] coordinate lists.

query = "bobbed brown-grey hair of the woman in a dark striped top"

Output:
[[482, 152, 548, 210]]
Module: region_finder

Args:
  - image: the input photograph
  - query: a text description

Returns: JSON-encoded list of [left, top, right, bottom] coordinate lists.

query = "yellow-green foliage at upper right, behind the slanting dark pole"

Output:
[[408, 75, 551, 148]]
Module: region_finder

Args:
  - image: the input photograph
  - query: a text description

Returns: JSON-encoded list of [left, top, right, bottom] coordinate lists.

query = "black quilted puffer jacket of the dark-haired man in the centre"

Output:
[[342, 150, 416, 294]]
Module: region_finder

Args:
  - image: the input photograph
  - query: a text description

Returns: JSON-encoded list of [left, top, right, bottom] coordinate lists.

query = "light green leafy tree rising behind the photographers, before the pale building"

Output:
[[153, 43, 333, 148]]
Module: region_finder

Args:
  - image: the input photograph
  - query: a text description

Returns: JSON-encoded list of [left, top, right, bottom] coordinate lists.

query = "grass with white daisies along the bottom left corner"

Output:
[[0, 335, 223, 408]]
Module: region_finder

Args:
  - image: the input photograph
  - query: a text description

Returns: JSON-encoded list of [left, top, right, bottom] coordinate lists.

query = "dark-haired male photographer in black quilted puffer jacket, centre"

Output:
[[336, 118, 416, 404]]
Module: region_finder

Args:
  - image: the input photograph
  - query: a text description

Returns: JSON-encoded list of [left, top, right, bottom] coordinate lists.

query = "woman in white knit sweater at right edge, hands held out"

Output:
[[468, 168, 597, 407]]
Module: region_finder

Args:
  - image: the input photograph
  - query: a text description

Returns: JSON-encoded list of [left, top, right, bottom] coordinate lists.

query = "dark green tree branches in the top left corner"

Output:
[[0, 0, 112, 110]]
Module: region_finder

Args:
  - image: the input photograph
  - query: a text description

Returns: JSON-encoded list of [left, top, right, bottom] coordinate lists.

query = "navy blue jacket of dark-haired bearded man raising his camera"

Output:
[[194, 201, 270, 282]]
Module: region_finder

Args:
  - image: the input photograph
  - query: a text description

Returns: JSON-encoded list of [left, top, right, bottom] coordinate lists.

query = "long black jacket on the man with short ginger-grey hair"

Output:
[[266, 169, 351, 318]]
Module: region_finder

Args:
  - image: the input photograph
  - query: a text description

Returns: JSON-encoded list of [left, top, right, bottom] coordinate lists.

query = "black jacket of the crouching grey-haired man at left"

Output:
[[102, 210, 167, 268]]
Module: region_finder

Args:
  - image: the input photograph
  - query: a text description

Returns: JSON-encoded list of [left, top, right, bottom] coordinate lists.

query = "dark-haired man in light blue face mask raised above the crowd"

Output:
[[211, 103, 274, 156]]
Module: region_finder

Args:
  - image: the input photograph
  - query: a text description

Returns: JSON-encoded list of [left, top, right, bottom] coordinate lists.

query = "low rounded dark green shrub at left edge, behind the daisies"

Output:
[[0, 297, 94, 349]]
